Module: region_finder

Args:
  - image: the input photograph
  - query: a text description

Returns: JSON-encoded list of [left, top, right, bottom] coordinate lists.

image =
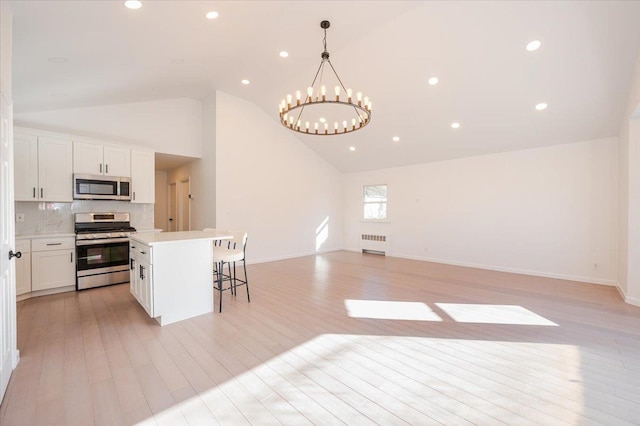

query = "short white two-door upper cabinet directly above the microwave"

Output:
[[73, 141, 131, 177]]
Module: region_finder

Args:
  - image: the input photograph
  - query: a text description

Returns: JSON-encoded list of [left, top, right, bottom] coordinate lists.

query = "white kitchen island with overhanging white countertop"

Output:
[[129, 231, 232, 325]]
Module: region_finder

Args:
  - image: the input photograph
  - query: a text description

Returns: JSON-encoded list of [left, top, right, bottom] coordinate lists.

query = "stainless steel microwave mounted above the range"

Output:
[[73, 174, 131, 201]]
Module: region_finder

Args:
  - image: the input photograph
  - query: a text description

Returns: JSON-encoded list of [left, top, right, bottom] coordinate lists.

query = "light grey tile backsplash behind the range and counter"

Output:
[[15, 200, 154, 236]]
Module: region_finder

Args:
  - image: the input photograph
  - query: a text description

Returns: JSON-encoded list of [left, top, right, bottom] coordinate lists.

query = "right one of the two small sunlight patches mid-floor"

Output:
[[436, 303, 558, 326]]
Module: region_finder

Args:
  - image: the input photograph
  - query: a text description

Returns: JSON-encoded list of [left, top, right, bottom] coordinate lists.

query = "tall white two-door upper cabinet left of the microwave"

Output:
[[14, 131, 73, 203]]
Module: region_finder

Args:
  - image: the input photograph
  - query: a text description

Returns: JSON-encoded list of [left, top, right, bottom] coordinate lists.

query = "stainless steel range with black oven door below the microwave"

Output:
[[74, 213, 136, 290]]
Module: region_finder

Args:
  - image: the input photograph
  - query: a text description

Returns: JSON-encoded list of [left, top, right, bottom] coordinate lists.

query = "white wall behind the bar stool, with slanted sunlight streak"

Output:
[[216, 92, 343, 262]]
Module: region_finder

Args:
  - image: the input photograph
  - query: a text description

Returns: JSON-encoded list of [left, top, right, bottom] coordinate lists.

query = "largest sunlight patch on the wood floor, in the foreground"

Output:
[[147, 334, 584, 424]]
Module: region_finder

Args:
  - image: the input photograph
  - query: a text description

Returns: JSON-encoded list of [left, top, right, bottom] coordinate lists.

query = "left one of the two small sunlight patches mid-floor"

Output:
[[344, 299, 442, 321]]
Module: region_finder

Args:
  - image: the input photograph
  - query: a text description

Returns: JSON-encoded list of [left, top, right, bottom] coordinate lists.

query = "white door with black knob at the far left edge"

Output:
[[0, 92, 17, 401]]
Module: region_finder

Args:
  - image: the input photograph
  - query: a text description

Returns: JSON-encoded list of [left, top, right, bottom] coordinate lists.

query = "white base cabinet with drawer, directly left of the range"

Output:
[[31, 237, 76, 291]]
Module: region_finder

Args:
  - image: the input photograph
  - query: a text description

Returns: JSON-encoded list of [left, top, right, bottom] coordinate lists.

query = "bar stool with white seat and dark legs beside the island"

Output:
[[213, 231, 251, 312]]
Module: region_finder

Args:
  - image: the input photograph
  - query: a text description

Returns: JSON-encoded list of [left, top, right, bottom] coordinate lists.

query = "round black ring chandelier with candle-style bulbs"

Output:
[[279, 21, 371, 136]]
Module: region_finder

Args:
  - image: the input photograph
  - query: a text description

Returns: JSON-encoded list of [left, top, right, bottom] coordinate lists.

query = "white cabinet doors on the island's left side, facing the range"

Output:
[[129, 241, 154, 318]]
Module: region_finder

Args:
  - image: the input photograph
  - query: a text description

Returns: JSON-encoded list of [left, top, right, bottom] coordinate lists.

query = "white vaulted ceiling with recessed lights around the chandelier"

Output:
[[11, 0, 640, 172]]
